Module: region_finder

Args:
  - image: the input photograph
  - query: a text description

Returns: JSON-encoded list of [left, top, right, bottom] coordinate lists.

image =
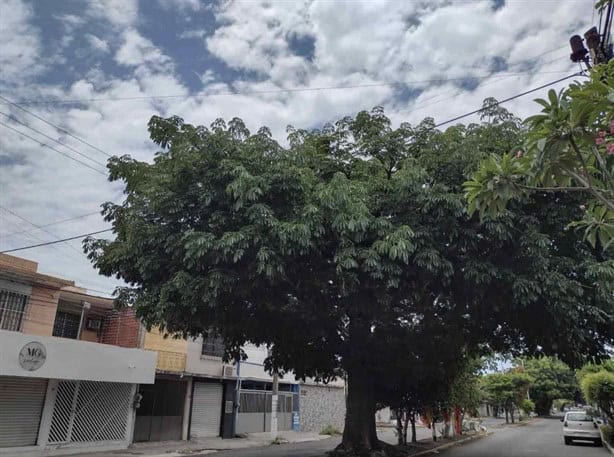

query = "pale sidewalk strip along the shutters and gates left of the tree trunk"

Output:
[[61, 431, 330, 457]]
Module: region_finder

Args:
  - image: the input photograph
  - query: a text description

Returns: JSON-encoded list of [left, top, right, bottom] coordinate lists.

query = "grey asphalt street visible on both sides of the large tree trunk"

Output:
[[215, 419, 607, 457]]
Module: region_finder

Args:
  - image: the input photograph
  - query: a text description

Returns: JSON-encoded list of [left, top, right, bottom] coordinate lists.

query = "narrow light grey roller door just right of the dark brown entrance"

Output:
[[190, 382, 222, 438]]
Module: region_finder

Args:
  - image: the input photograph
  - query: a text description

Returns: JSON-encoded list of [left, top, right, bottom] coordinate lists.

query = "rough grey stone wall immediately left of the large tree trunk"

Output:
[[299, 384, 345, 433]]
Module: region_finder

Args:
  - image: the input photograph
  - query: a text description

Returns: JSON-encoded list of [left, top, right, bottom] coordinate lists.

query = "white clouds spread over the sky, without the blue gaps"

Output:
[[0, 0, 592, 290]]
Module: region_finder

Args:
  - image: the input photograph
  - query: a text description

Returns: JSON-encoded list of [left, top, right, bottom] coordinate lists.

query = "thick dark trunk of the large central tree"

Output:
[[337, 369, 381, 448]]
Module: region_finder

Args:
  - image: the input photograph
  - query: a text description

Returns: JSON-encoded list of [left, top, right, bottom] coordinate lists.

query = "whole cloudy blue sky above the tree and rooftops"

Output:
[[0, 0, 596, 295]]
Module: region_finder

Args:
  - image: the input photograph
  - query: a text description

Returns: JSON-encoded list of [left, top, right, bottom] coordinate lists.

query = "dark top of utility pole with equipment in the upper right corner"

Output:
[[569, 0, 614, 70]]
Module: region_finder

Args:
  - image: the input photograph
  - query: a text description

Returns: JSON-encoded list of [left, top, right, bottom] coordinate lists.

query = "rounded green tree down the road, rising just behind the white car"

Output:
[[522, 357, 578, 416]]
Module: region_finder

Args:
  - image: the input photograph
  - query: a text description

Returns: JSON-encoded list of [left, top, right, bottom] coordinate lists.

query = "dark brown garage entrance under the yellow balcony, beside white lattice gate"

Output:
[[134, 379, 186, 442]]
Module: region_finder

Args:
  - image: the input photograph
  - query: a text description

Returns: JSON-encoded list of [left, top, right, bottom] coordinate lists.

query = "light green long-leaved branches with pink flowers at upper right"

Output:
[[464, 61, 614, 250]]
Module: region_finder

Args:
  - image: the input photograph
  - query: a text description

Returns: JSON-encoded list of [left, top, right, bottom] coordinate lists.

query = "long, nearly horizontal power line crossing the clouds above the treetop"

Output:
[[0, 70, 567, 106]]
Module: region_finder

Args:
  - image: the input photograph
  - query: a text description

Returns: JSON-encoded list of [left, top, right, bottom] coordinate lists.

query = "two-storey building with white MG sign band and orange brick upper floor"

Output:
[[0, 254, 156, 456]]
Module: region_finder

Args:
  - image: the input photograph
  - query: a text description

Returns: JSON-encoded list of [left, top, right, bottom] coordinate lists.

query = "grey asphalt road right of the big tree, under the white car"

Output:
[[440, 419, 608, 457]]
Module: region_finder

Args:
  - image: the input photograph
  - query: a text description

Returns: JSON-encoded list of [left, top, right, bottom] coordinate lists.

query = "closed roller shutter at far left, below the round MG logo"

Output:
[[0, 376, 47, 448]]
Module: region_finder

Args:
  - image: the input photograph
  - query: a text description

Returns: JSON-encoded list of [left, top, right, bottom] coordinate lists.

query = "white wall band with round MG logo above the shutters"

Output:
[[0, 330, 156, 384]]
